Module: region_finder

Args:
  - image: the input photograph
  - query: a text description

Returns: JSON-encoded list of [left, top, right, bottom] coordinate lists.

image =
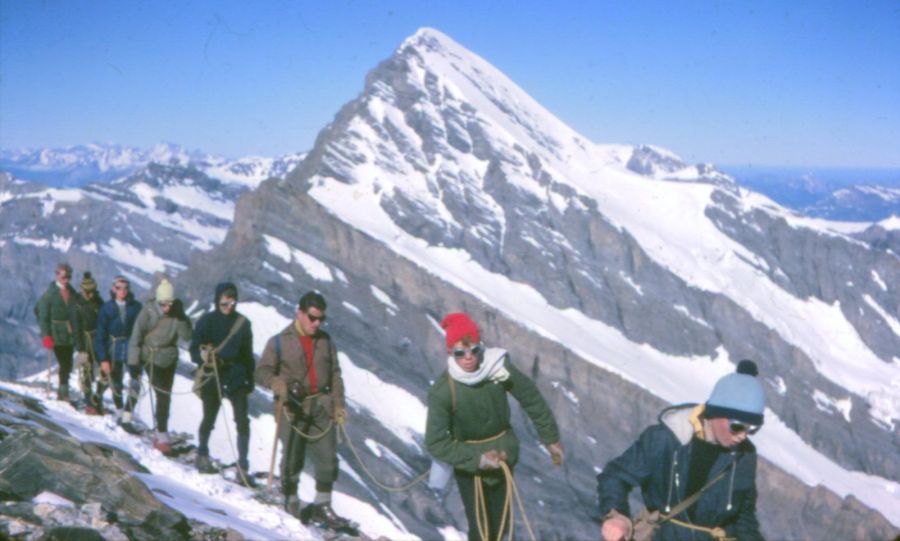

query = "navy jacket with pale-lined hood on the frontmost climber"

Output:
[[597, 404, 762, 541]]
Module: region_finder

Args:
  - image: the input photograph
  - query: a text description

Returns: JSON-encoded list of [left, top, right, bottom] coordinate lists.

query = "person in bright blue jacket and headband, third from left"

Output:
[[94, 276, 143, 421]]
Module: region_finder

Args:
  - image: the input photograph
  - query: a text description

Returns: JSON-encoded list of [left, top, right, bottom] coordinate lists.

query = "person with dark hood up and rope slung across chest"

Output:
[[190, 282, 256, 480]]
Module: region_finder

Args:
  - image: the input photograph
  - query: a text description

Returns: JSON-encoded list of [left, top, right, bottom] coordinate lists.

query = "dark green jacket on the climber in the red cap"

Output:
[[425, 356, 559, 474]]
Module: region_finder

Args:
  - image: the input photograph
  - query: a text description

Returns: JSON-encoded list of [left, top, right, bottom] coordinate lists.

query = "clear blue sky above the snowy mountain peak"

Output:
[[0, 0, 900, 167]]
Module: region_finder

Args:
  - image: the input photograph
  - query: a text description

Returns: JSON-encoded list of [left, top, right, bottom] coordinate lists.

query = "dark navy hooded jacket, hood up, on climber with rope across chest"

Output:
[[190, 282, 256, 396]]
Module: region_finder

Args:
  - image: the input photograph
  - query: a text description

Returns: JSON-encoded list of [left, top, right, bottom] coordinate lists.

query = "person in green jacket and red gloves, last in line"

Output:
[[36, 263, 83, 400]]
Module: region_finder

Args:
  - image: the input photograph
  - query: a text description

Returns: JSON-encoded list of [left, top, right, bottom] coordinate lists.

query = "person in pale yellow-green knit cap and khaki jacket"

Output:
[[122, 278, 192, 454]]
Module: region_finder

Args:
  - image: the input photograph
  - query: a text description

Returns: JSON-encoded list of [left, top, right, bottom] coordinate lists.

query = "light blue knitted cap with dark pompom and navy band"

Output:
[[704, 360, 766, 426]]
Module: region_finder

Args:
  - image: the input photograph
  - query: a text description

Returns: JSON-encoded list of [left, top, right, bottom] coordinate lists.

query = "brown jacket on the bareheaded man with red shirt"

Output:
[[256, 321, 344, 413]]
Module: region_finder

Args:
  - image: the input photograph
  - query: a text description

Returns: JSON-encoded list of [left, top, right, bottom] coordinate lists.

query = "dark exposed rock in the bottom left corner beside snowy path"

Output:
[[0, 390, 190, 541]]
